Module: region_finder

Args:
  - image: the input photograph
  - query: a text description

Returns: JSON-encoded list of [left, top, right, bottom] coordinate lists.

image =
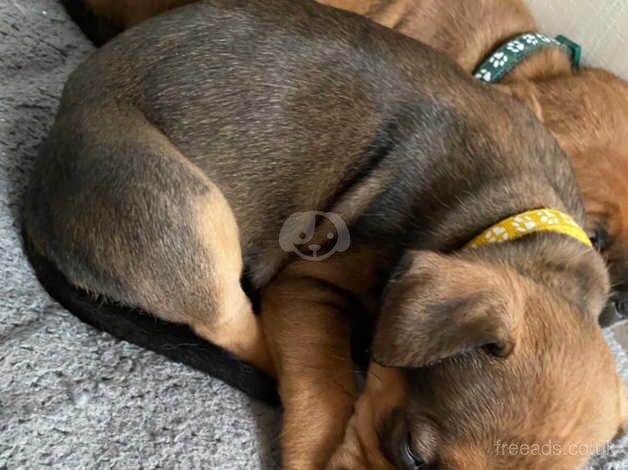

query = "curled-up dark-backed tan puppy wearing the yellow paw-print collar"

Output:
[[23, 0, 626, 470]]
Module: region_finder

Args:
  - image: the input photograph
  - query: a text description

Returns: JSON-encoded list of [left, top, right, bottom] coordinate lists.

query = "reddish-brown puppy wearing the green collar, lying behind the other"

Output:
[[319, 0, 628, 326]]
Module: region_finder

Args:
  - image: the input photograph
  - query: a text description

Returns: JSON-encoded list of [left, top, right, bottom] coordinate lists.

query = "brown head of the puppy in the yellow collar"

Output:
[[332, 252, 626, 470]]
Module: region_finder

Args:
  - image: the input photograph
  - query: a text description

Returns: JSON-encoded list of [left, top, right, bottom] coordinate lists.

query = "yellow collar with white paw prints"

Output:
[[465, 209, 592, 248]]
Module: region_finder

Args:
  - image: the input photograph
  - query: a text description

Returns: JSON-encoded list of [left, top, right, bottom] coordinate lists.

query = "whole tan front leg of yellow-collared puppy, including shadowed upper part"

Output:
[[262, 243, 382, 470]]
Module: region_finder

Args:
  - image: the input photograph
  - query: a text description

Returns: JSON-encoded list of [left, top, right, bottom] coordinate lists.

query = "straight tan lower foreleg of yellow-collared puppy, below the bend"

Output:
[[261, 272, 355, 470]]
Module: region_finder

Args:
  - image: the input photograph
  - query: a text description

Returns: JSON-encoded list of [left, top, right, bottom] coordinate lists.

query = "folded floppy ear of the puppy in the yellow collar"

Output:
[[372, 252, 523, 367]]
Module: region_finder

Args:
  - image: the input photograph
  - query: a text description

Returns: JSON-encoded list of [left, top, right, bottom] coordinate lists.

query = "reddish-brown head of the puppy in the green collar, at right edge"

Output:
[[500, 69, 628, 325]]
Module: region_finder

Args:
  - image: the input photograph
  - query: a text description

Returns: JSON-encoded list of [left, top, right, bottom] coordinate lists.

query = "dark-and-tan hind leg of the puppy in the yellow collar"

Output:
[[24, 103, 272, 372]]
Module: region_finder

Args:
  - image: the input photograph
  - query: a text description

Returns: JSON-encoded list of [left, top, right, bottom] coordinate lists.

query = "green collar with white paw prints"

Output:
[[474, 33, 581, 83]]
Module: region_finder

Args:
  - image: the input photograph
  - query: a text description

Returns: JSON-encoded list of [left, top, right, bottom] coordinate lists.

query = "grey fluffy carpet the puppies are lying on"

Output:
[[0, 0, 628, 469]]
